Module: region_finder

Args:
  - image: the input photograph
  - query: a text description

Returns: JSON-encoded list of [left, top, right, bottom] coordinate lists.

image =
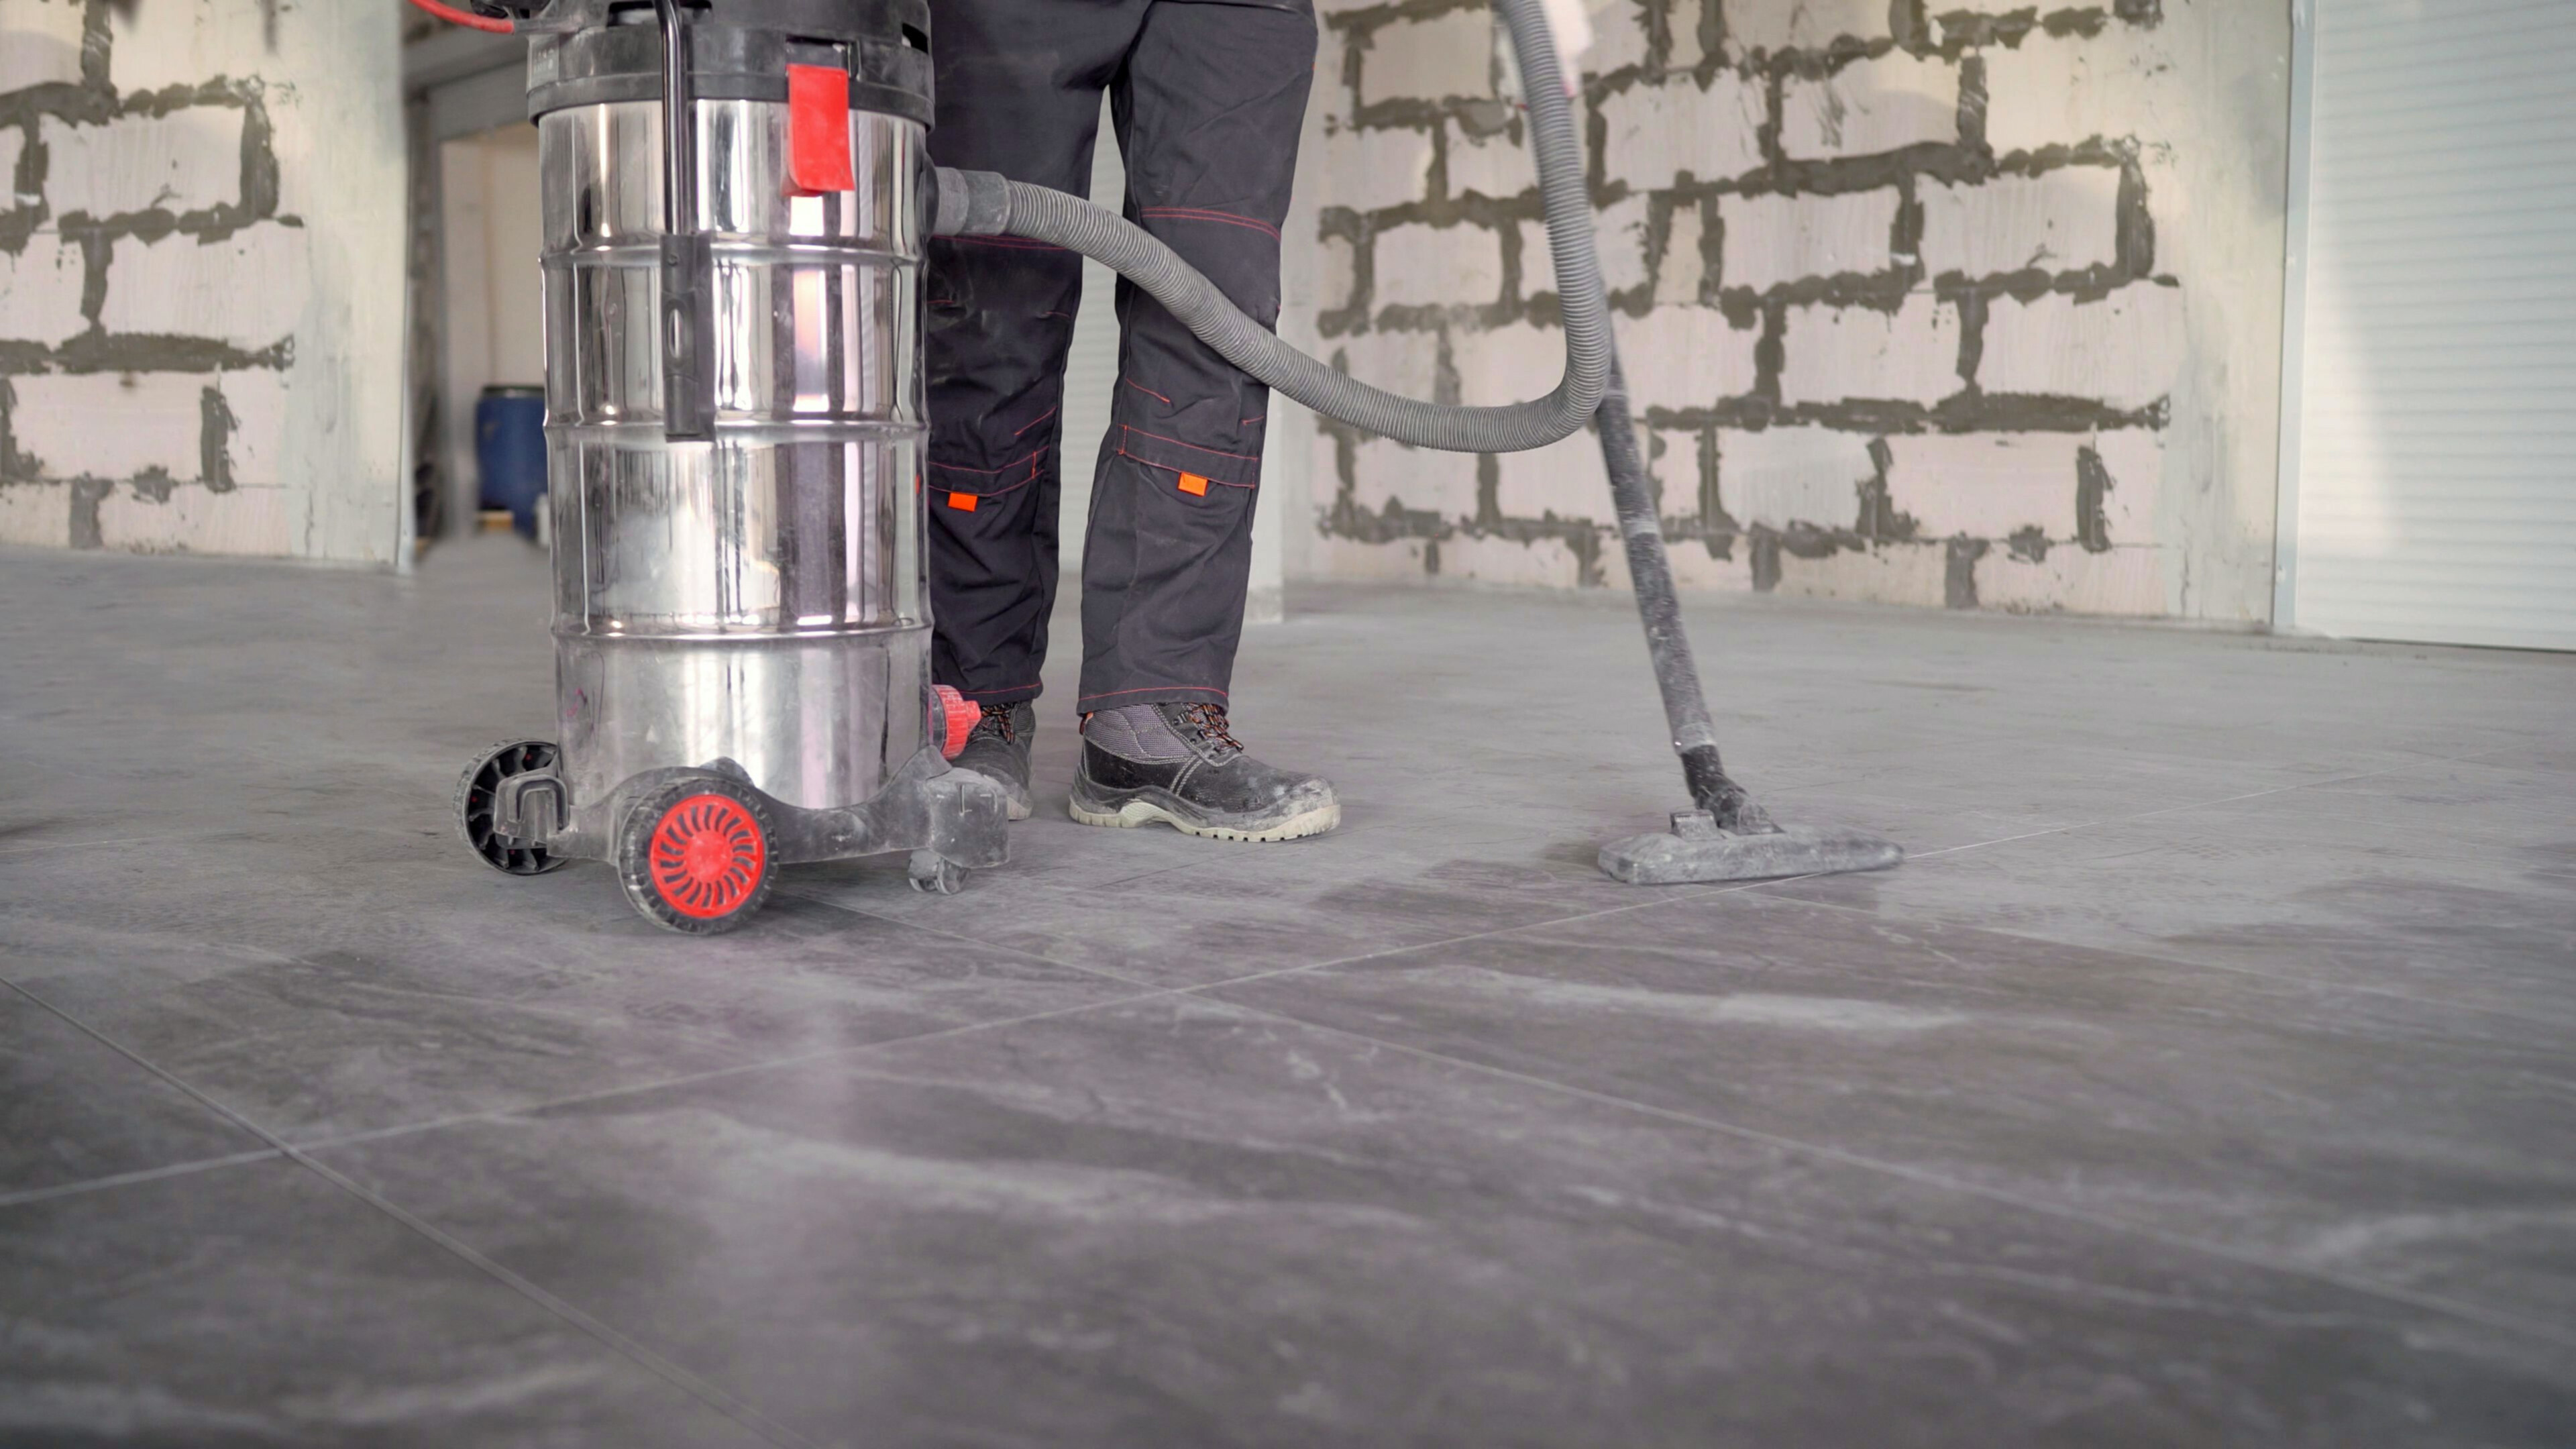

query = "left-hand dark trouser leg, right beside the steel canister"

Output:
[[925, 0, 1146, 711]]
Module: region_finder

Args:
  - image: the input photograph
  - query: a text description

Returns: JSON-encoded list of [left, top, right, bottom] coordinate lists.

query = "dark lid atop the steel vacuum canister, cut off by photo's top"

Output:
[[528, 0, 930, 126]]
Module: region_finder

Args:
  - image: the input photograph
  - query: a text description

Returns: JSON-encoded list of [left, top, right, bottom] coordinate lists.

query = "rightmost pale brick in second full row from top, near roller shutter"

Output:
[[1922, 165, 2120, 276]]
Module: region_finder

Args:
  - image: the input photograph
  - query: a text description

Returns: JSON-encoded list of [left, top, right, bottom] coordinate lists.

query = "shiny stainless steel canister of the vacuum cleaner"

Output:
[[539, 101, 930, 807]]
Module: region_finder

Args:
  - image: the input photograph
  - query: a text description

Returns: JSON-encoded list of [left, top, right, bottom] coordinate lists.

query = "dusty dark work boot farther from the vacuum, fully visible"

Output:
[[1074, 704, 1342, 841]]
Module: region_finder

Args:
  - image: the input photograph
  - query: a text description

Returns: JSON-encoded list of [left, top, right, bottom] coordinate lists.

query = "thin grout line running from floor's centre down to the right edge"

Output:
[[1226, 1000, 2576, 1348]]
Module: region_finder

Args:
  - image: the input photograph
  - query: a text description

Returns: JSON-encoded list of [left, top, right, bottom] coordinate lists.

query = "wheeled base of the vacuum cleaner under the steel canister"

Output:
[[456, 740, 1010, 936]]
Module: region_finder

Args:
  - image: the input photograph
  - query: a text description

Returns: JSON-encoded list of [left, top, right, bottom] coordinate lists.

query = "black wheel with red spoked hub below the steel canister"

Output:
[[616, 776, 778, 936]]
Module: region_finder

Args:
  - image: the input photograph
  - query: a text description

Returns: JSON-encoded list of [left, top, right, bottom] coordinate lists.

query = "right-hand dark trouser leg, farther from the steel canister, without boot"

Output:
[[1079, 0, 1313, 712]]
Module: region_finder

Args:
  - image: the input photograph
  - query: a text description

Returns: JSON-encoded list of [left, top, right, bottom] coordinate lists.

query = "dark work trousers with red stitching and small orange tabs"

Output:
[[927, 0, 1313, 712]]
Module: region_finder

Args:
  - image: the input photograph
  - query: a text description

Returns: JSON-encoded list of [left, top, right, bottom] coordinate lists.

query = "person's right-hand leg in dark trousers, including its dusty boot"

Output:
[[1071, 0, 1342, 841]]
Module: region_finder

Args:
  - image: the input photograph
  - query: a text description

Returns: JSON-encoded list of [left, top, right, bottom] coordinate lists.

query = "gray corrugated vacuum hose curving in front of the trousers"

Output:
[[930, 0, 1610, 453]]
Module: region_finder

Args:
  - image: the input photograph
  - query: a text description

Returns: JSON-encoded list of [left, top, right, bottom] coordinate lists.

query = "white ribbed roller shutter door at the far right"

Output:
[[2279, 0, 2576, 650]]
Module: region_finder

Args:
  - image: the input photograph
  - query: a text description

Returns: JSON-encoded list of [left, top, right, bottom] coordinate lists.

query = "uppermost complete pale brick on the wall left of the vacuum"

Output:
[[39, 106, 245, 219]]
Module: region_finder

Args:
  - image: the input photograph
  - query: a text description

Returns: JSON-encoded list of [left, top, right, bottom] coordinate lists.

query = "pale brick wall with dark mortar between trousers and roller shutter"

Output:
[[1288, 0, 2290, 621]]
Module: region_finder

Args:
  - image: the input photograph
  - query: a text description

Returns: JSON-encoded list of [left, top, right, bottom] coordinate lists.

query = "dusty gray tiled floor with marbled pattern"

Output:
[[0, 541, 2576, 1449]]
